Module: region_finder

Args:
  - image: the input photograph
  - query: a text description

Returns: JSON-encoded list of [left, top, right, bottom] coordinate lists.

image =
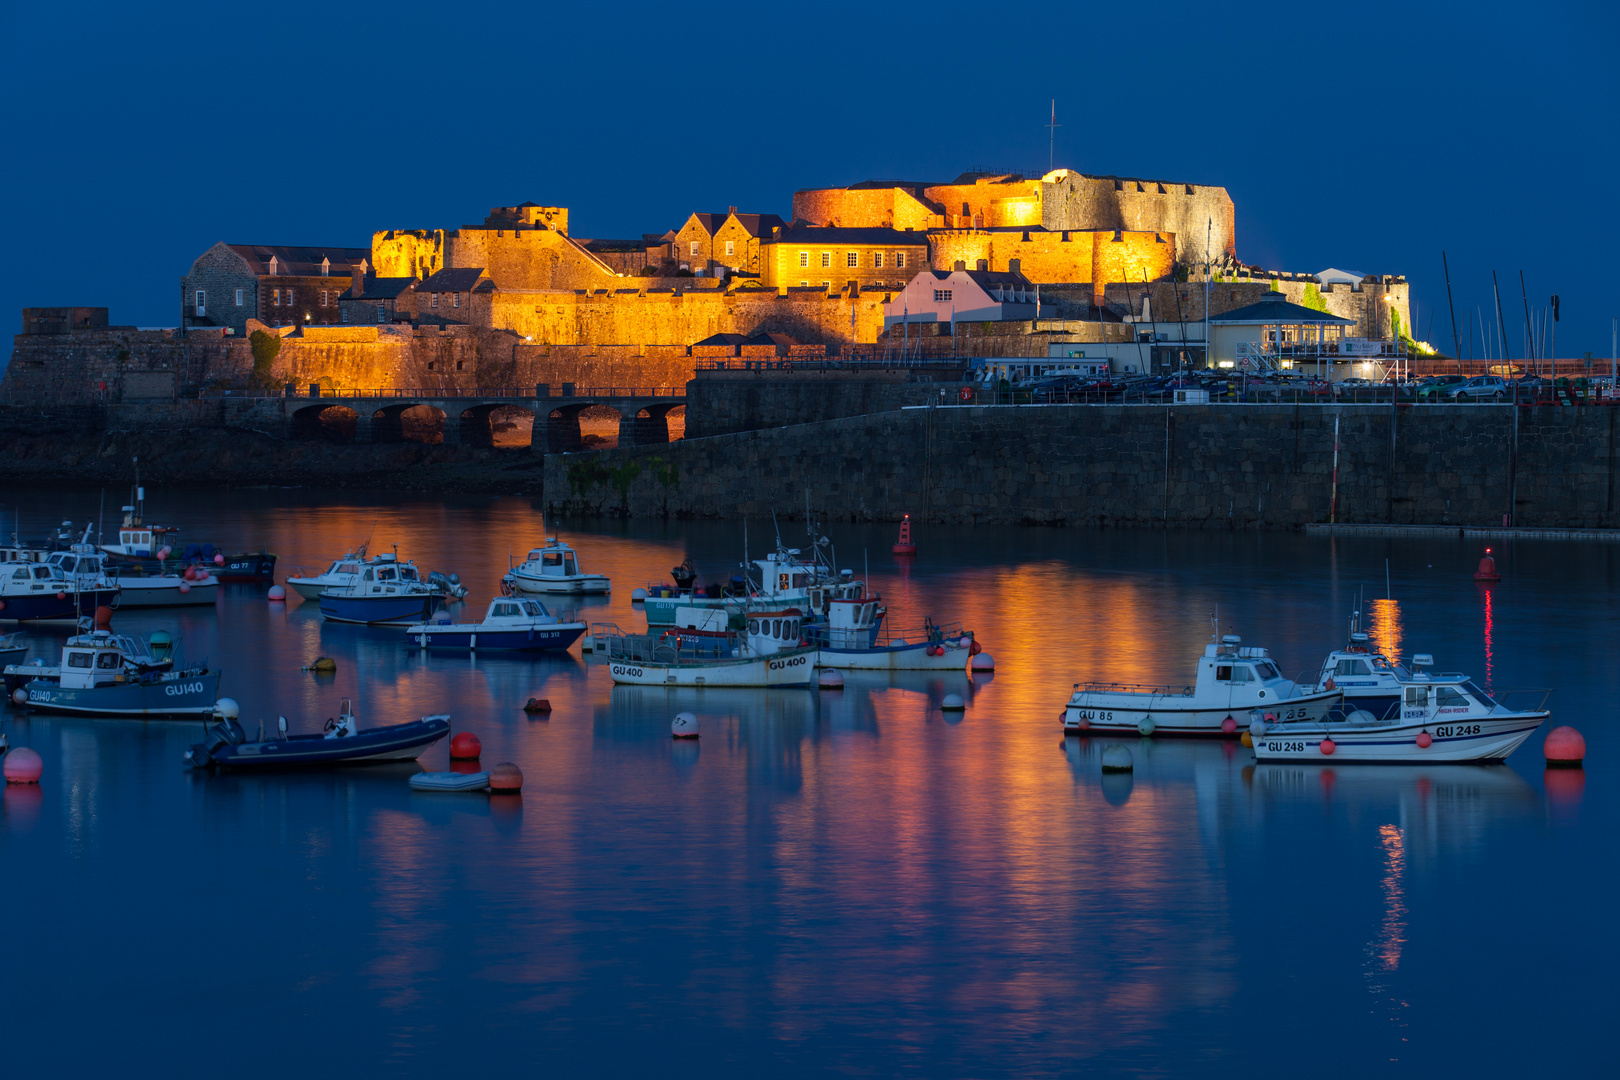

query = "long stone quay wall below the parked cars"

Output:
[[544, 405, 1620, 528]]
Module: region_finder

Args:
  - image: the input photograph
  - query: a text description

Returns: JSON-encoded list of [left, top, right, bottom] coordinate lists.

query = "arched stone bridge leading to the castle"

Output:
[[282, 382, 687, 453]]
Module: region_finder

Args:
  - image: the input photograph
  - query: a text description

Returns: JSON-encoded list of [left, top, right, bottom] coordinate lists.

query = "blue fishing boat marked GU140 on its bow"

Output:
[[3, 625, 219, 717]]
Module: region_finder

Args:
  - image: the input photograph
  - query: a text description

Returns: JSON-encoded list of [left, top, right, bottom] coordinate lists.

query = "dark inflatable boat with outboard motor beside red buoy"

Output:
[[185, 698, 450, 769]]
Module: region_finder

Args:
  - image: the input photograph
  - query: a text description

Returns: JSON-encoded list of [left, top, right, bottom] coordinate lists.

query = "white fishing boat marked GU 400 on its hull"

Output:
[[593, 607, 816, 687]]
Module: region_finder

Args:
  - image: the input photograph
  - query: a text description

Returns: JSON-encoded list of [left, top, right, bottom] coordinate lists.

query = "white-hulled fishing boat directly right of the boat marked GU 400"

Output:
[[805, 578, 982, 672]]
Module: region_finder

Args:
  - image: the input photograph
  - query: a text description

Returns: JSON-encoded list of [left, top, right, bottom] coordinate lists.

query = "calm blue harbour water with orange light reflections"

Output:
[[0, 489, 1620, 1077]]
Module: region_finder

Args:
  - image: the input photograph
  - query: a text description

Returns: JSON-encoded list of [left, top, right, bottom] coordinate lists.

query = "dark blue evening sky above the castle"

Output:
[[0, 2, 1620, 356]]
